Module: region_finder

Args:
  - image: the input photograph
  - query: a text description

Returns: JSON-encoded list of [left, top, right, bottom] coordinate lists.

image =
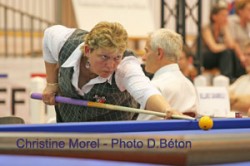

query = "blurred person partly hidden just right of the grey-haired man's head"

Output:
[[178, 45, 197, 82]]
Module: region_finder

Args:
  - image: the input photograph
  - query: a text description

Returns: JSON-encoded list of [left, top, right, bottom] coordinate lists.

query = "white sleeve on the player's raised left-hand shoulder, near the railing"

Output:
[[43, 25, 75, 63]]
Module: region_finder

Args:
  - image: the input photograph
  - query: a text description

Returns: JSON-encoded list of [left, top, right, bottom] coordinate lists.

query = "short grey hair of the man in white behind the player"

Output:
[[150, 28, 183, 62]]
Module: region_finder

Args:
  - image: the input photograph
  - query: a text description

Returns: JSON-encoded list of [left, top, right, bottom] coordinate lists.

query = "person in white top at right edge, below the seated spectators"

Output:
[[229, 40, 250, 115]]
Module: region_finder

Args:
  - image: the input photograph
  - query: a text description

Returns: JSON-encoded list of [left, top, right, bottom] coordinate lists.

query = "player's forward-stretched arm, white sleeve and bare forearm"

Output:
[[116, 56, 170, 112]]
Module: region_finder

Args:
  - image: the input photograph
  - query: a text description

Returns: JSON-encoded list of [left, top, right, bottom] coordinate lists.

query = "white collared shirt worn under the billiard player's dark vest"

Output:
[[43, 25, 160, 108]]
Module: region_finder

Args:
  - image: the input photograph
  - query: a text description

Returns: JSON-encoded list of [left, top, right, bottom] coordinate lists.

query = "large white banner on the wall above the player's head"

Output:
[[72, 0, 155, 36]]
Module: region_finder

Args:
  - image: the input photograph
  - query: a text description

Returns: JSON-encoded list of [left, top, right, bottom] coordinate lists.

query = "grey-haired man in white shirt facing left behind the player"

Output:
[[137, 29, 198, 120]]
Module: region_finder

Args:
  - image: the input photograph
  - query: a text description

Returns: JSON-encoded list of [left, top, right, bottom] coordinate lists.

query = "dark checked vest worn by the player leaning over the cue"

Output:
[[56, 29, 137, 122]]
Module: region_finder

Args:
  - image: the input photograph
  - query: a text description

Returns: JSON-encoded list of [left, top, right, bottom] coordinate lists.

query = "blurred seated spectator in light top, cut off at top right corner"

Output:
[[228, 0, 250, 77]]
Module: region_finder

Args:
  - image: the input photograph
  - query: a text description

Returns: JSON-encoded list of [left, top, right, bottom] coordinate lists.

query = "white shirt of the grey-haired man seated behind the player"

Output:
[[137, 64, 198, 120]]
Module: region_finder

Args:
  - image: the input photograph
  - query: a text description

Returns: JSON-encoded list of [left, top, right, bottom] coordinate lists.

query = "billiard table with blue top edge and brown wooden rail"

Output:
[[0, 118, 250, 165]]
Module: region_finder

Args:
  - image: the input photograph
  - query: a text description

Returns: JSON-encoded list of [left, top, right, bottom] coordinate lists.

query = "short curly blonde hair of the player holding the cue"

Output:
[[85, 21, 128, 53]]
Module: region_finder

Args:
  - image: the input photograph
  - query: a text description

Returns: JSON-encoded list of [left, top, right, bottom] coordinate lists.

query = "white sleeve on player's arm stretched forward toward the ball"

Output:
[[115, 56, 160, 108]]
